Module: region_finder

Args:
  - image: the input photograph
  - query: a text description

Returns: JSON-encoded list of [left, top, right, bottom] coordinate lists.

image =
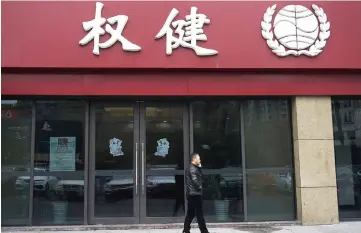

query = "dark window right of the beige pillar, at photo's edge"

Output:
[[332, 98, 361, 219]]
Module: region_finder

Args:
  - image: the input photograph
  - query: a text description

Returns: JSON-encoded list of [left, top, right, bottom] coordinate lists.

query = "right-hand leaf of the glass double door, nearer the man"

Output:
[[139, 103, 189, 223]]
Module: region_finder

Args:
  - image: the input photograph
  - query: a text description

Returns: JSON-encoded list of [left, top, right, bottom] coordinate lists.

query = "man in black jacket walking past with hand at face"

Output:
[[183, 153, 209, 233]]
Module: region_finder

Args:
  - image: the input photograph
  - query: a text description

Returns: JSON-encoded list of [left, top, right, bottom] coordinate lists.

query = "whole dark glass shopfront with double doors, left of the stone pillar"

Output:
[[2, 97, 295, 226]]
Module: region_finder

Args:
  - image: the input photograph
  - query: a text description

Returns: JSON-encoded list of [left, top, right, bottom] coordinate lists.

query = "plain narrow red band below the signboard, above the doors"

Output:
[[1, 72, 361, 96]]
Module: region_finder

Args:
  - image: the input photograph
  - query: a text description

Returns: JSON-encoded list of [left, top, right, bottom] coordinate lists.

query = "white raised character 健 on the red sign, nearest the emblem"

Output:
[[155, 7, 218, 56]]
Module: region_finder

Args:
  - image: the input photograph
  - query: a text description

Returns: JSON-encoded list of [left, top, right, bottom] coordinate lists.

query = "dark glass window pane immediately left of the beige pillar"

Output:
[[244, 100, 295, 221]]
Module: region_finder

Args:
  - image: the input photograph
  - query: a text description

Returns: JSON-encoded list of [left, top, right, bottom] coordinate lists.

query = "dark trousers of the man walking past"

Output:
[[183, 195, 208, 233]]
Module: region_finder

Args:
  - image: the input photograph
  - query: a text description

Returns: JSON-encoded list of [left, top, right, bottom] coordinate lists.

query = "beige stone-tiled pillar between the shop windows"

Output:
[[292, 97, 339, 225]]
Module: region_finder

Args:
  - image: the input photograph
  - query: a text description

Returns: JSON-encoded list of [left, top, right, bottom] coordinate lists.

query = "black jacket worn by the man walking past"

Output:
[[185, 164, 203, 196]]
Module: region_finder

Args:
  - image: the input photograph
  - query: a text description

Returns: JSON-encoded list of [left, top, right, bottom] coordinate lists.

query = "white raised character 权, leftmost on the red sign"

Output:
[[79, 2, 141, 55]]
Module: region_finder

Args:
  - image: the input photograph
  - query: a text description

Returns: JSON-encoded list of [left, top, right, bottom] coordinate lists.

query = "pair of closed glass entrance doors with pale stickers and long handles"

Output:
[[88, 102, 189, 224]]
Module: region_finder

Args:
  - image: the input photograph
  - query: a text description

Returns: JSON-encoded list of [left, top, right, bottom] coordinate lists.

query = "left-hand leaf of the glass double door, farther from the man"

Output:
[[89, 103, 140, 224]]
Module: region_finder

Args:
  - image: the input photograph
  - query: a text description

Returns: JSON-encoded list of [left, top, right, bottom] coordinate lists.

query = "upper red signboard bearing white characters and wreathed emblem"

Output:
[[1, 1, 361, 69]]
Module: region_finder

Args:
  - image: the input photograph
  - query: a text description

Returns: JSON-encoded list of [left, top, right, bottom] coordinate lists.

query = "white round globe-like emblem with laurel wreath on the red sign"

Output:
[[261, 5, 330, 57]]
